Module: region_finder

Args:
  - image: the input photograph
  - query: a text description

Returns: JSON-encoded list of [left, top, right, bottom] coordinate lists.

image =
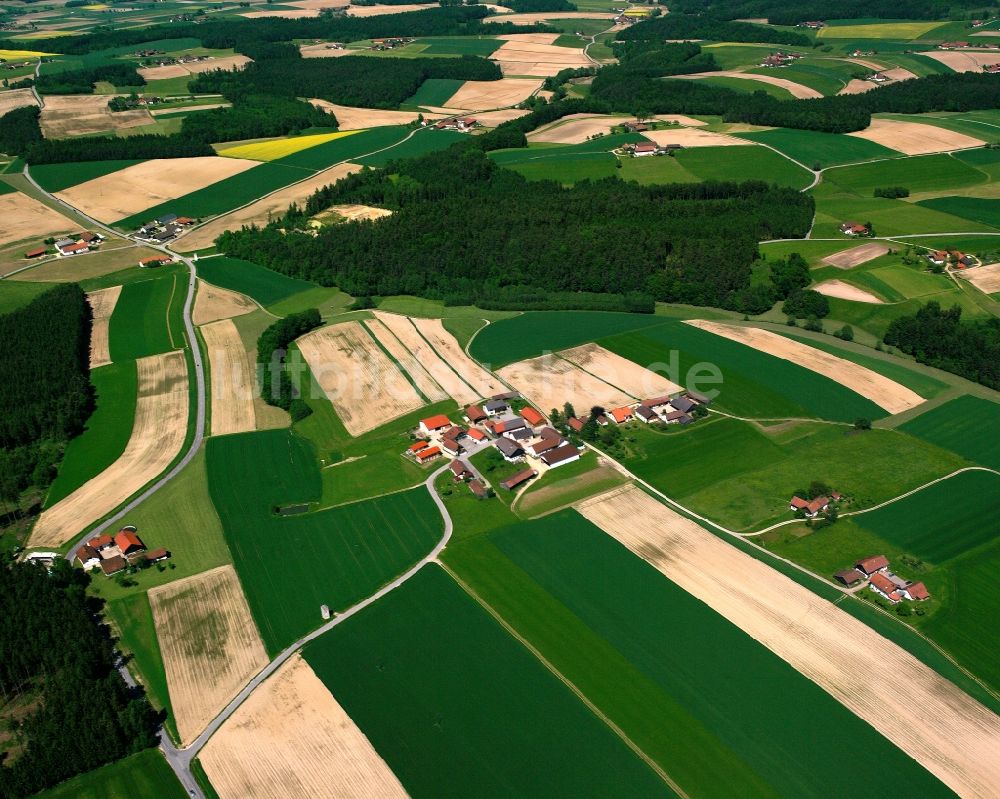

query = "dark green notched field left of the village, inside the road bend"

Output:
[[206, 430, 442, 654]]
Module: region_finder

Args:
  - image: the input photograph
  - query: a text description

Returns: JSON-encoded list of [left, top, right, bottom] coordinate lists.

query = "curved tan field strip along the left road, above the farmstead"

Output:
[[29, 351, 188, 546]]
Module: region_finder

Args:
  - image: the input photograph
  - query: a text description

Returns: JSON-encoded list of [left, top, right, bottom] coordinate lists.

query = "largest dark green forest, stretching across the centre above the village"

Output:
[[218, 140, 814, 313]]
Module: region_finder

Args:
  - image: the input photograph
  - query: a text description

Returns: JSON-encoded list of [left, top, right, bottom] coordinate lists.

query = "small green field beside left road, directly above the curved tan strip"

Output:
[[108, 270, 187, 363]]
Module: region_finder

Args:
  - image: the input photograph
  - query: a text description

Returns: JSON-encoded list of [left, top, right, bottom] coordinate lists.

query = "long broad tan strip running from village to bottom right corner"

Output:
[[578, 487, 1000, 797]]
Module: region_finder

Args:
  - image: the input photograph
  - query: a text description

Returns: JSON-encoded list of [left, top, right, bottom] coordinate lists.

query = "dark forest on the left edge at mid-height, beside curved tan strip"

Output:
[[0, 283, 94, 502]]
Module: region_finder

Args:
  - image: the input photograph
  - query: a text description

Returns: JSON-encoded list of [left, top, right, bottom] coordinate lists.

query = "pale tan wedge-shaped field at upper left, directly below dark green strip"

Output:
[[56, 155, 259, 222]]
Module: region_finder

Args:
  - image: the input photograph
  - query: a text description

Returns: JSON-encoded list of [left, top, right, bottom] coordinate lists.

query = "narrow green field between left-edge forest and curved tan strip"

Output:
[[45, 361, 138, 507]]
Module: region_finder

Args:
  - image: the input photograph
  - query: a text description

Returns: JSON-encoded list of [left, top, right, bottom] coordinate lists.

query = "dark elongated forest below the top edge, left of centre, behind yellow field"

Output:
[[191, 51, 502, 109]]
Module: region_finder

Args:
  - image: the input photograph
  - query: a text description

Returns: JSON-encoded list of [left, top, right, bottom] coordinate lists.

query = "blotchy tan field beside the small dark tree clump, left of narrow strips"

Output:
[[298, 322, 423, 436]]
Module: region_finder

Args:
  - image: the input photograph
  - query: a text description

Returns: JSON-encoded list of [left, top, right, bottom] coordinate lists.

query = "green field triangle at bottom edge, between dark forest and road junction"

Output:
[[36, 749, 187, 799]]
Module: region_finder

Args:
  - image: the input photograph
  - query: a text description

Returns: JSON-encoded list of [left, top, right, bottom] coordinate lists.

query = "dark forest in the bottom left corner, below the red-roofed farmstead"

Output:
[[0, 559, 159, 799]]
